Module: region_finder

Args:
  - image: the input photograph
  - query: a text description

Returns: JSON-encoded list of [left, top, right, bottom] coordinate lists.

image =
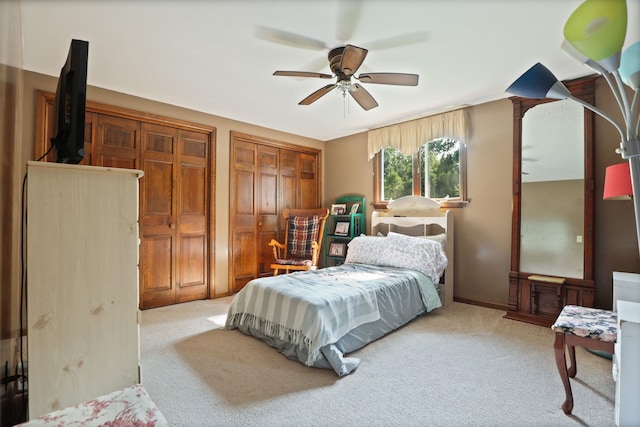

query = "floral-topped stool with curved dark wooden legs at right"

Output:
[[551, 305, 617, 415]]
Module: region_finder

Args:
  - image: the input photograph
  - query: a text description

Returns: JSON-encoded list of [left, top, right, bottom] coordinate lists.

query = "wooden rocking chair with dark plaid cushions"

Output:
[[269, 209, 329, 276]]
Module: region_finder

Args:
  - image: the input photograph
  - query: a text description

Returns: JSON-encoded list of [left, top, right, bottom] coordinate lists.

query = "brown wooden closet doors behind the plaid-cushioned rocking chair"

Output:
[[229, 132, 320, 293]]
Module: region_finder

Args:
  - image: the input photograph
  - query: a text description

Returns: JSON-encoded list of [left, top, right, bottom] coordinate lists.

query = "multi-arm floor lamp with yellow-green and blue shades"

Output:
[[507, 0, 640, 258]]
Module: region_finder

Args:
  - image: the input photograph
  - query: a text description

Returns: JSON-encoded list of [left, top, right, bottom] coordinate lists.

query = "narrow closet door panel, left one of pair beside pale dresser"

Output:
[[140, 123, 179, 308]]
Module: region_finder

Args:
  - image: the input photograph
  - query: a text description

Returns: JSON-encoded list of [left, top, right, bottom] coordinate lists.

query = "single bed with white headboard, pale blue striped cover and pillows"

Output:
[[225, 197, 453, 377]]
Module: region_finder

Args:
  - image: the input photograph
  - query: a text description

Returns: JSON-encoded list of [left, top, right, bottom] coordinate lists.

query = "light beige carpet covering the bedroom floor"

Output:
[[140, 298, 615, 427]]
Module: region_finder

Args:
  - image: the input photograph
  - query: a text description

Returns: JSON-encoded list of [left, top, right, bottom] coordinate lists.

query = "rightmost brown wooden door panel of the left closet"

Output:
[[176, 130, 209, 302]]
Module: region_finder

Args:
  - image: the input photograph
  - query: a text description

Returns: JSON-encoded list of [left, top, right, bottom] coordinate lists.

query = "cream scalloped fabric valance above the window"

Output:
[[369, 110, 469, 160]]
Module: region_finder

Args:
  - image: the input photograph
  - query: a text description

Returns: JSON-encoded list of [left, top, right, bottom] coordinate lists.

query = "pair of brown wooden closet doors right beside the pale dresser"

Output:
[[140, 123, 208, 308]]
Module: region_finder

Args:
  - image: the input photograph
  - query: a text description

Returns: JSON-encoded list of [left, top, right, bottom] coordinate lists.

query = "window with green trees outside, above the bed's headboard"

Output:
[[374, 138, 466, 208]]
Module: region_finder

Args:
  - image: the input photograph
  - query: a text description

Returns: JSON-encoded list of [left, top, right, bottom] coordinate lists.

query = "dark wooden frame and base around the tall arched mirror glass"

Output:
[[505, 76, 598, 326]]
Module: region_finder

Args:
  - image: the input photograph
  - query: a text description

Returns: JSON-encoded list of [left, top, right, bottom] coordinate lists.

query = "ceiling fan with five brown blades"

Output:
[[273, 44, 418, 110]]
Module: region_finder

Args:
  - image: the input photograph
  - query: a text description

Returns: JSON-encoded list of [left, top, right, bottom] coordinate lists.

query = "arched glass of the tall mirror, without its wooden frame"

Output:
[[520, 100, 585, 279]]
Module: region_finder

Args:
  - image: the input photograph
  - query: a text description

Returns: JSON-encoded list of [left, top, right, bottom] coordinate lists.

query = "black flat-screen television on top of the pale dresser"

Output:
[[51, 39, 89, 164]]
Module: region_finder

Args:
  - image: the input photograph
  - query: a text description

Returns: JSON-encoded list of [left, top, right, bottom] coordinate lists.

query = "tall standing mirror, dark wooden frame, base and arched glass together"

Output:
[[505, 76, 598, 326]]
